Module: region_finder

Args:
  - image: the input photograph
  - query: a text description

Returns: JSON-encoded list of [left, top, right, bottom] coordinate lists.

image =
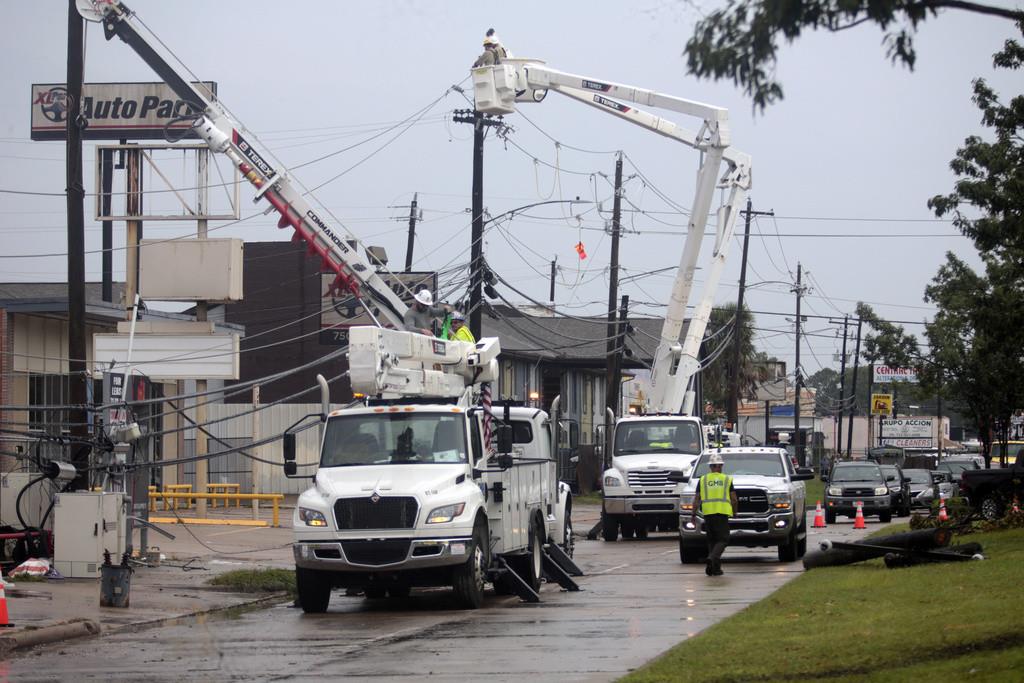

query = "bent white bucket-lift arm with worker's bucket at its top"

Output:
[[473, 59, 751, 414]]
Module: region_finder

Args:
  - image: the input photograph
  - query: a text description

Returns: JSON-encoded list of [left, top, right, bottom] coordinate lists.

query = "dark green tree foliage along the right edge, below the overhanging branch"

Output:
[[857, 28, 1024, 464]]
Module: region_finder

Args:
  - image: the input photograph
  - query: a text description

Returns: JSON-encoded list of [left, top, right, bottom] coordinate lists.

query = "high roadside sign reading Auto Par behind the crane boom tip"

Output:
[[32, 81, 217, 140]]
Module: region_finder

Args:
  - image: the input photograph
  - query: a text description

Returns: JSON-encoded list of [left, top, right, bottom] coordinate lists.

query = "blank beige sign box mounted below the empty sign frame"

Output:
[[139, 238, 244, 302]]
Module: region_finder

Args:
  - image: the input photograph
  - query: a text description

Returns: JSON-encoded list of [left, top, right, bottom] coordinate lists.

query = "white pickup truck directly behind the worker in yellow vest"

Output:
[[672, 446, 814, 563]]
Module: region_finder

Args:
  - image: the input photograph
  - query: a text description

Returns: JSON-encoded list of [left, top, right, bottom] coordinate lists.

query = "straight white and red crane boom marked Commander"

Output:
[[77, 0, 408, 329]]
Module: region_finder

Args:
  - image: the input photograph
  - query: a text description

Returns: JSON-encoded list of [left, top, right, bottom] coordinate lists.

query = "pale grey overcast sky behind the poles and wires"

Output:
[[0, 0, 1022, 374]]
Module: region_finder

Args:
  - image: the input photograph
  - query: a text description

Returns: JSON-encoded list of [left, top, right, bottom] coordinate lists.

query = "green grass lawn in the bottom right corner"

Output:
[[623, 529, 1024, 683]]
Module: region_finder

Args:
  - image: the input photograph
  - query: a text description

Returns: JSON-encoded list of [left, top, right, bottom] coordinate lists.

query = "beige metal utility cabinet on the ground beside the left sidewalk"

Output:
[[53, 493, 126, 579]]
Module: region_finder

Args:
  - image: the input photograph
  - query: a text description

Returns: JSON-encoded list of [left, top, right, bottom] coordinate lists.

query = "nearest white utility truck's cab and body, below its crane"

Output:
[[285, 402, 573, 612]]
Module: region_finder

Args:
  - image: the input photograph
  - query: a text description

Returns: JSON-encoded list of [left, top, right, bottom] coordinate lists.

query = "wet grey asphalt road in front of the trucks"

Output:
[[6, 511, 880, 683]]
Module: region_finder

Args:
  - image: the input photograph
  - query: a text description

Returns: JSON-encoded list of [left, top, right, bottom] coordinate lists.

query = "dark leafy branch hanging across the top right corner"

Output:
[[685, 0, 1024, 111]]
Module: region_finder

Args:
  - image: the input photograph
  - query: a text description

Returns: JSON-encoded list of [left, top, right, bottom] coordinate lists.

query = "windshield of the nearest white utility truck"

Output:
[[321, 413, 467, 467]]
